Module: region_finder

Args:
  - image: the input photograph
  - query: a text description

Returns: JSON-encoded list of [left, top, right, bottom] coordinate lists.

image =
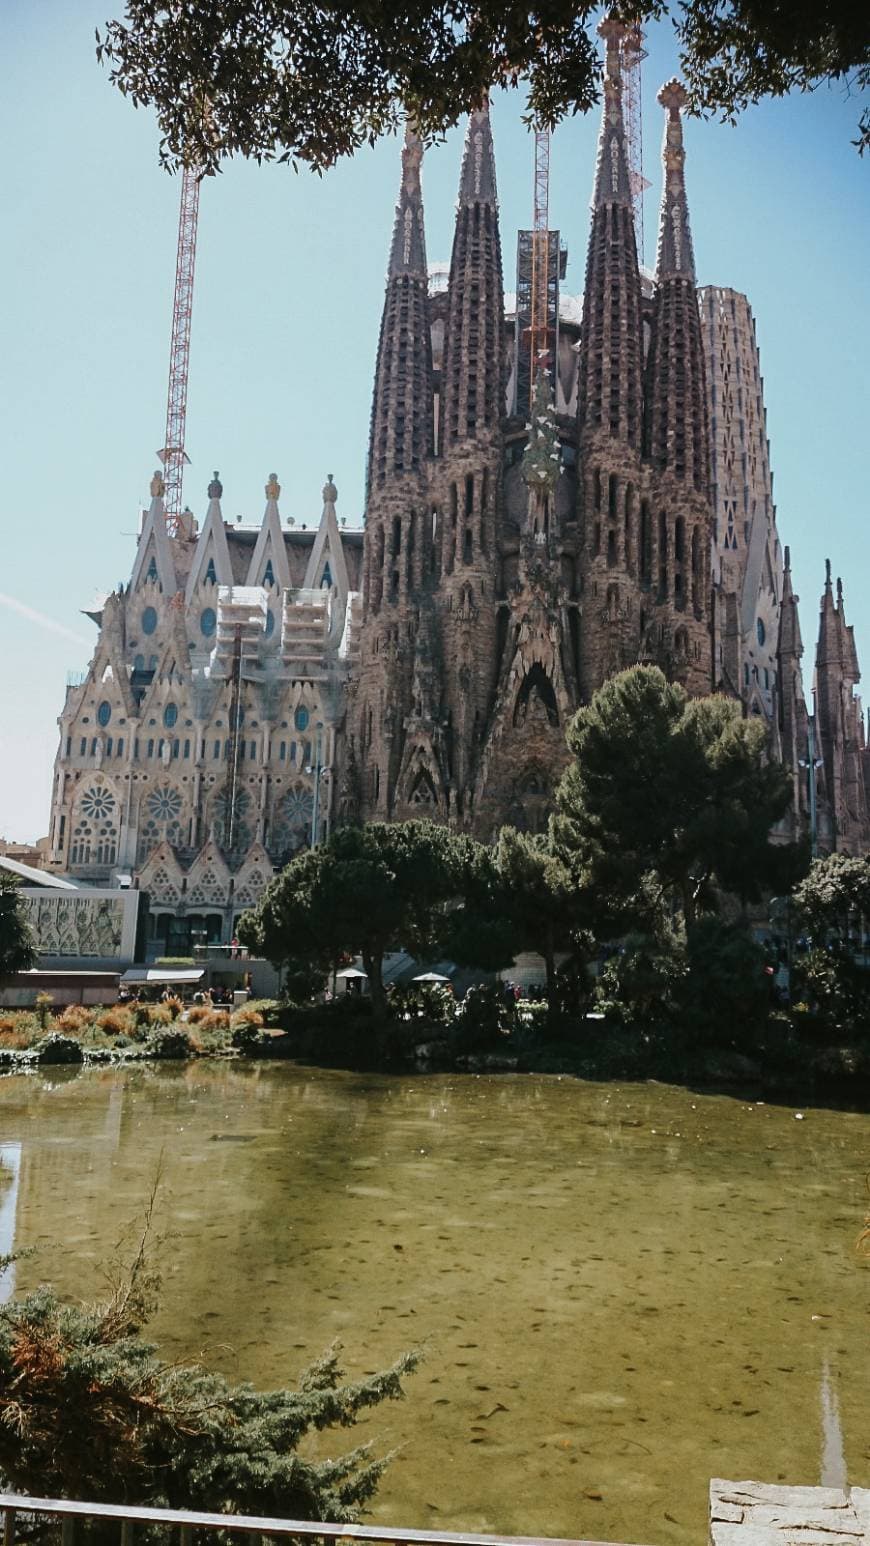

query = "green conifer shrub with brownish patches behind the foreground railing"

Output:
[[0, 1252, 416, 1521]]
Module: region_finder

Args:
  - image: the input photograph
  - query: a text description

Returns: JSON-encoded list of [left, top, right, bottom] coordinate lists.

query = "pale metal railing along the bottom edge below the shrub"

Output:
[[0, 1492, 627, 1546]]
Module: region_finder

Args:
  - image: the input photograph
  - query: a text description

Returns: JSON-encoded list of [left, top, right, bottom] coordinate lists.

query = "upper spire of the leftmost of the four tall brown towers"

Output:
[[369, 127, 433, 495]]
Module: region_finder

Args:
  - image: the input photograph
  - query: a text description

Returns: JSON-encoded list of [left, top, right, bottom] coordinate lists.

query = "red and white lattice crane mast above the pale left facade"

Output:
[[158, 165, 199, 536]]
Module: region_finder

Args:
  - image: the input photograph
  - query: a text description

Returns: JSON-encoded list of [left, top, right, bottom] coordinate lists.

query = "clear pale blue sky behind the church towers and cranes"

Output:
[[0, 0, 870, 839]]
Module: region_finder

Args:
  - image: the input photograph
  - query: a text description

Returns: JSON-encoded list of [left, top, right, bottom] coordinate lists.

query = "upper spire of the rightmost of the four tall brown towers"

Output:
[[646, 80, 709, 493]]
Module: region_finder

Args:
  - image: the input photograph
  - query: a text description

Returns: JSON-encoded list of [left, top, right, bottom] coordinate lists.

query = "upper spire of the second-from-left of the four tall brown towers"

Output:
[[440, 108, 504, 451]]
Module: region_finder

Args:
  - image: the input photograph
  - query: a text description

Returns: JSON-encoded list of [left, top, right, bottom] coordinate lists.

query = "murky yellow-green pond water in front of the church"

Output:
[[0, 1062, 870, 1543]]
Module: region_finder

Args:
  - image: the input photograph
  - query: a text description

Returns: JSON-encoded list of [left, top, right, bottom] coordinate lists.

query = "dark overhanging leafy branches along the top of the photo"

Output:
[[97, 0, 870, 172]]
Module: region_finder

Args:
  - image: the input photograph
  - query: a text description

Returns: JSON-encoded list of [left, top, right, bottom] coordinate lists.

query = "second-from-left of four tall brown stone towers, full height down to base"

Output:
[[433, 108, 505, 824]]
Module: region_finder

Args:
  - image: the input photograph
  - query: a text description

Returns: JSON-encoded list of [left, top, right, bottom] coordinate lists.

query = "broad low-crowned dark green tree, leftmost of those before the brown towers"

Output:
[[238, 821, 474, 1017]]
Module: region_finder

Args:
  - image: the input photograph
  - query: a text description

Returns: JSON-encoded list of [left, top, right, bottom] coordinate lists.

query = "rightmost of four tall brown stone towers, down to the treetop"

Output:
[[644, 80, 712, 693]]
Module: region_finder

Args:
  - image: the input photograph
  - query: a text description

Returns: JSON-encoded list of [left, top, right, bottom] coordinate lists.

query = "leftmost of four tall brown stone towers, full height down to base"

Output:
[[349, 127, 434, 818]]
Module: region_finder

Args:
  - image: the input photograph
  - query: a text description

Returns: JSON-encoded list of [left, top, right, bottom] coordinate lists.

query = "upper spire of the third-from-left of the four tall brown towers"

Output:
[[578, 17, 643, 451]]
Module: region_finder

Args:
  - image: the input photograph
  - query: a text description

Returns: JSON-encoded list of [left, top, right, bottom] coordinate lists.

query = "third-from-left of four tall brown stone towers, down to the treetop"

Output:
[[578, 17, 649, 699]]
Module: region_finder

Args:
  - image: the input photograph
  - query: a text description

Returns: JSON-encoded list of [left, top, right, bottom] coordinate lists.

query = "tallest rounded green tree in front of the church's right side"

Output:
[[556, 666, 805, 928]]
